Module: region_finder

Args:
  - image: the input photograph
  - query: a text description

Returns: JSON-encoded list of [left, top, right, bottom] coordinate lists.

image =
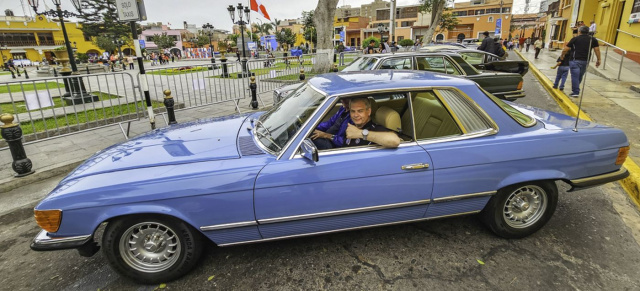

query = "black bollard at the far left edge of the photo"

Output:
[[0, 113, 34, 177]]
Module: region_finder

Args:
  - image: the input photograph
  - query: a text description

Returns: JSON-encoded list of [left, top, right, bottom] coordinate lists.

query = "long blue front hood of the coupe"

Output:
[[63, 114, 247, 182]]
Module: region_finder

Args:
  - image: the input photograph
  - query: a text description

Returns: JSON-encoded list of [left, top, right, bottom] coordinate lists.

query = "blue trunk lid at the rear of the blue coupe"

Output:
[[505, 101, 609, 130]]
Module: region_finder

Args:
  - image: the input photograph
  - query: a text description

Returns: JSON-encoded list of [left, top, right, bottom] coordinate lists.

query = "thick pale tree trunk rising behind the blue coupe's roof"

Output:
[[313, 0, 339, 72]]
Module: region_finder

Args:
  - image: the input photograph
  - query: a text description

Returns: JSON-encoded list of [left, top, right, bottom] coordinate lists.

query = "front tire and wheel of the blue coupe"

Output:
[[102, 216, 203, 284]]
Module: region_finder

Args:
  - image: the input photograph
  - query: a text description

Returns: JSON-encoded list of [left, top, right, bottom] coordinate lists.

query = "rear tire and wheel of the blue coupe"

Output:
[[481, 181, 558, 238]]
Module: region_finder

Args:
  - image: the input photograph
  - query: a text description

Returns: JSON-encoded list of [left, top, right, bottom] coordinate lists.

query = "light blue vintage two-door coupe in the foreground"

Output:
[[31, 70, 629, 284]]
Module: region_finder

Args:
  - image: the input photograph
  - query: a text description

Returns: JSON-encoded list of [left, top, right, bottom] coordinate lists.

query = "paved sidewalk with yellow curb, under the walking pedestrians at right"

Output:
[[517, 50, 640, 207]]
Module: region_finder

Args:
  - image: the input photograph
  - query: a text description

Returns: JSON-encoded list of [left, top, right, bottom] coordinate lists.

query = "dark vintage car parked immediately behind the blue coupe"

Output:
[[342, 51, 525, 100]]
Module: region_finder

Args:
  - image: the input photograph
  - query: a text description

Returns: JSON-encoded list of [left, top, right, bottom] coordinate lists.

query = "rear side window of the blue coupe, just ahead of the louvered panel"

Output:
[[402, 91, 462, 140]]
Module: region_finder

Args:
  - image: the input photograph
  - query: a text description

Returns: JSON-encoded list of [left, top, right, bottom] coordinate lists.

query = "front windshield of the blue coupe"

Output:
[[253, 84, 326, 153]]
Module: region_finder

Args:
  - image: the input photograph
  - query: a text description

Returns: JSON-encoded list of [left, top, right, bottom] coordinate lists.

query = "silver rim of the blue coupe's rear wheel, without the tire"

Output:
[[502, 185, 548, 228]]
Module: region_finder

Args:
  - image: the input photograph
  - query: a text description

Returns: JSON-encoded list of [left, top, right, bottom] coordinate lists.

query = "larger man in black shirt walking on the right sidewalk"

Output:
[[560, 26, 600, 97]]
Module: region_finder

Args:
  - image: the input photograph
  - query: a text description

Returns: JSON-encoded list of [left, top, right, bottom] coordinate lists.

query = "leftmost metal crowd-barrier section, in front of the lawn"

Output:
[[0, 73, 144, 149]]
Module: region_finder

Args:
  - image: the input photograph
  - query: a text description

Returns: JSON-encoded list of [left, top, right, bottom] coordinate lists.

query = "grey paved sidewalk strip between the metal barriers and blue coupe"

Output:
[[0, 92, 273, 195]]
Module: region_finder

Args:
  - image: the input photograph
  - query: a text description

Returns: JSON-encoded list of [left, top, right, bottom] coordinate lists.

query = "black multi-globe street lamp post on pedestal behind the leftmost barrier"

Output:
[[28, 0, 99, 105]]
